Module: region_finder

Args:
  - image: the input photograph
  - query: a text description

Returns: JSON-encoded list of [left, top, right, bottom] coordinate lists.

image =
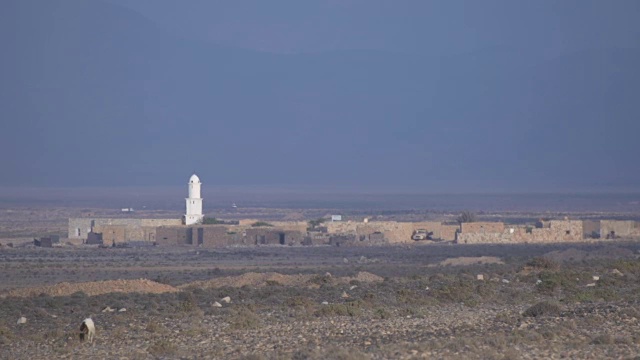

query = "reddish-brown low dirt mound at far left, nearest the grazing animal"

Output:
[[4, 279, 179, 297]]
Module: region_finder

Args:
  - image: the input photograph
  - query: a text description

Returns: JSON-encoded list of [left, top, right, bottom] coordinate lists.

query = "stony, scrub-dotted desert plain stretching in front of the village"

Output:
[[0, 242, 640, 359]]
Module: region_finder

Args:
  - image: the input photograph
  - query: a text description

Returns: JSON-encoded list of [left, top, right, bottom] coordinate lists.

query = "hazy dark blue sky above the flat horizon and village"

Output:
[[0, 0, 640, 192]]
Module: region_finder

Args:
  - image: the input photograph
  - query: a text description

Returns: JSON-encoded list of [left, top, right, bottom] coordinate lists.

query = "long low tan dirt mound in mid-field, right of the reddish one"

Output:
[[180, 272, 384, 289]]
